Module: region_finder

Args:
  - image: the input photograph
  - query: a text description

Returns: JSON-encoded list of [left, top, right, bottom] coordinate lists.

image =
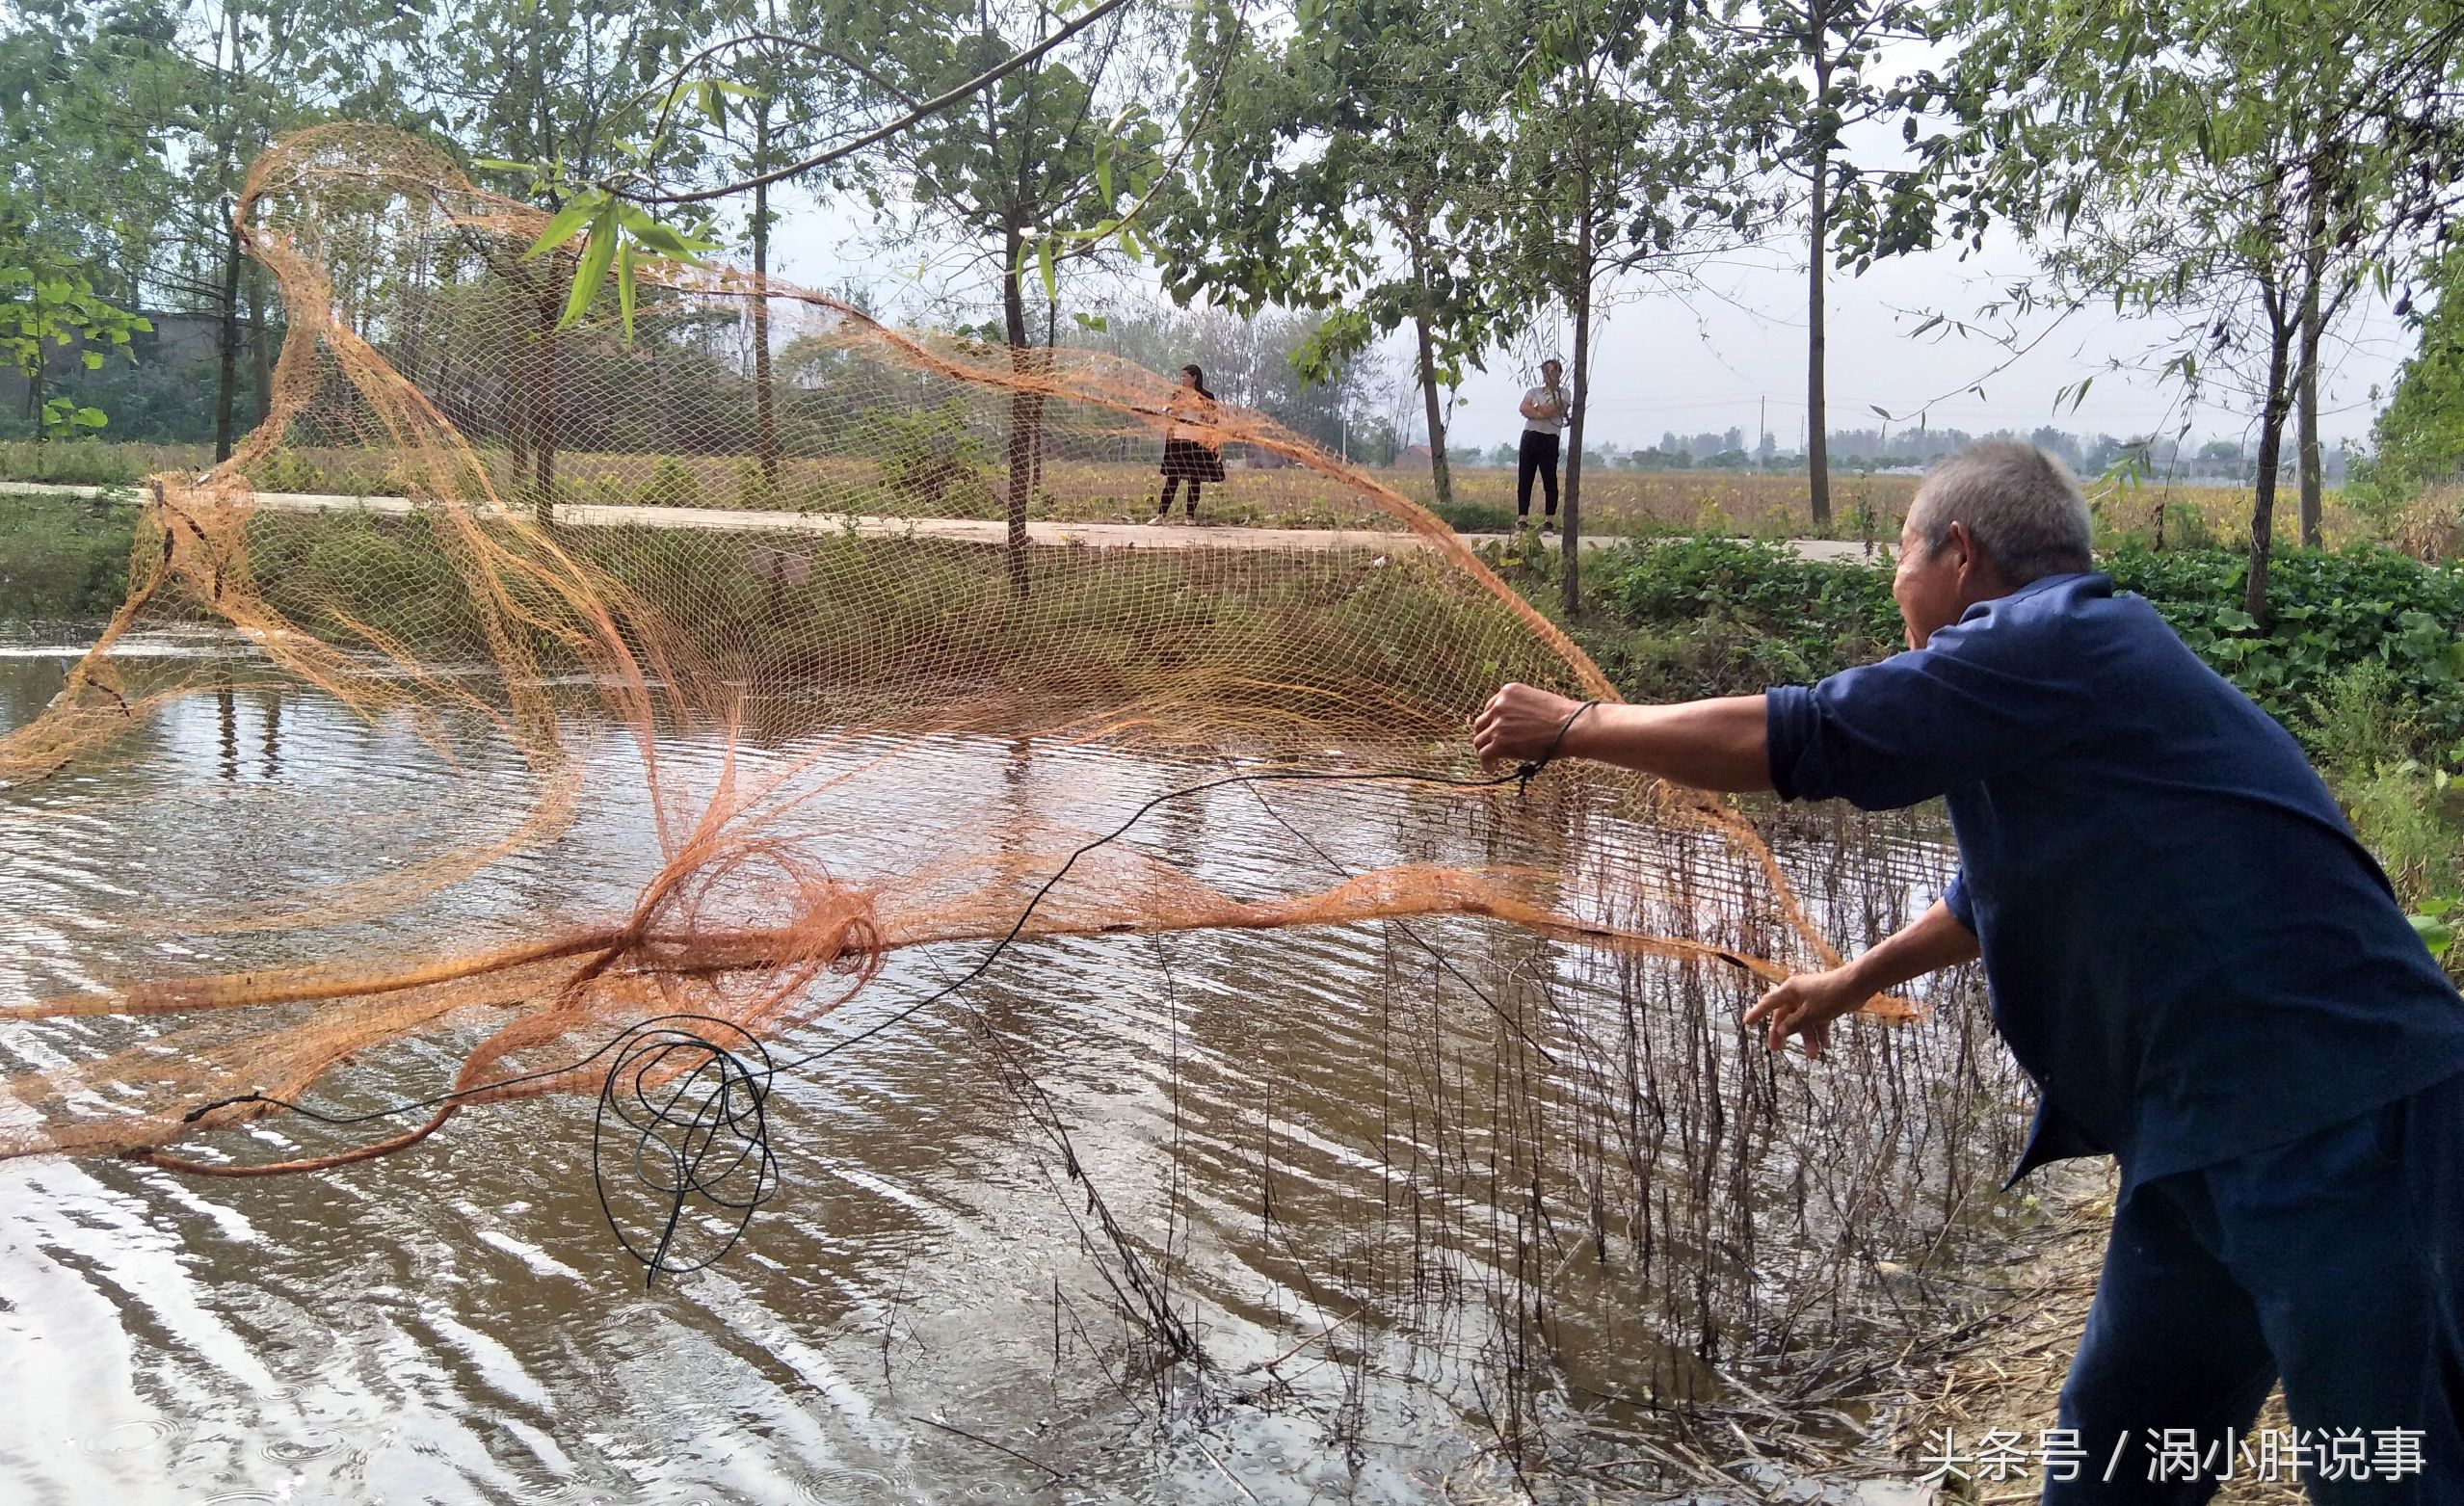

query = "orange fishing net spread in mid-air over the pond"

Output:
[[0, 125, 1905, 1174]]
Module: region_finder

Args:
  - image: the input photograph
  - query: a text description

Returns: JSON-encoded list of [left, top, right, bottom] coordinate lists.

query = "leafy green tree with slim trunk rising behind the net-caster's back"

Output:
[[1917, 0, 2410, 621]]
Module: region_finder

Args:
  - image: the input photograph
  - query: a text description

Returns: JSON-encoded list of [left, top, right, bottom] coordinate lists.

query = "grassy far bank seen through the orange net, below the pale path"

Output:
[[0, 498, 1562, 739]]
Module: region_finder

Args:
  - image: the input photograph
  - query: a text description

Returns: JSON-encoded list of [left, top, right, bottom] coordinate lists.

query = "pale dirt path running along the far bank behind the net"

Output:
[[0, 481, 1868, 560]]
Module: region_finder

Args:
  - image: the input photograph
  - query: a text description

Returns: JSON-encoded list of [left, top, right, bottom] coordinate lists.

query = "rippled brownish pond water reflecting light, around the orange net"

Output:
[[0, 621, 2016, 1501]]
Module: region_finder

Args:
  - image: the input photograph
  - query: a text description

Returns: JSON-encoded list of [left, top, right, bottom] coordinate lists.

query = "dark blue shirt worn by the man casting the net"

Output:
[[1766, 574, 2464, 1191]]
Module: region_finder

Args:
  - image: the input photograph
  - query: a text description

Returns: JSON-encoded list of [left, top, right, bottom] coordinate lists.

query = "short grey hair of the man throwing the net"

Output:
[[1907, 438, 2094, 587]]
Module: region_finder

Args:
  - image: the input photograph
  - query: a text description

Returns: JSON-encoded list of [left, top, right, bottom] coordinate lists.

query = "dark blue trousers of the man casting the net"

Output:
[[2045, 1077, 2464, 1506]]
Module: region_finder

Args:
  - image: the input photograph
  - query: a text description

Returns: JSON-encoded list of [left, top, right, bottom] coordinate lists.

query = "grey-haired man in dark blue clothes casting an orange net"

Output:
[[1473, 441, 2464, 1501]]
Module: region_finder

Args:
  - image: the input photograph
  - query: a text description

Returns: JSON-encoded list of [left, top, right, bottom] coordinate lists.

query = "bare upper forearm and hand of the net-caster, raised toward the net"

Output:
[[1471, 685, 1771, 791]]
